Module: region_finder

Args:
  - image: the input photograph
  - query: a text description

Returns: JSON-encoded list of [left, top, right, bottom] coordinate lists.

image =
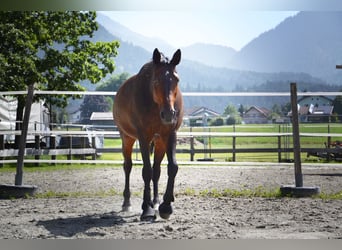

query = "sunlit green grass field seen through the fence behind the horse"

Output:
[[0, 123, 342, 171]]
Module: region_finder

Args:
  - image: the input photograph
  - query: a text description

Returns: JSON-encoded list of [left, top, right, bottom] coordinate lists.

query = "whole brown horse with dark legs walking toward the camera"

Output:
[[113, 49, 183, 220]]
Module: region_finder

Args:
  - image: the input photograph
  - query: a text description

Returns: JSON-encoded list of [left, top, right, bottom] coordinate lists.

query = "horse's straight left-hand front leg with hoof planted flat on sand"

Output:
[[139, 140, 156, 221]]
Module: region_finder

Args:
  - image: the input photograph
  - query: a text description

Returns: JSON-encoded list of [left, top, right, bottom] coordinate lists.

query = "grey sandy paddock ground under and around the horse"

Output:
[[0, 164, 342, 239]]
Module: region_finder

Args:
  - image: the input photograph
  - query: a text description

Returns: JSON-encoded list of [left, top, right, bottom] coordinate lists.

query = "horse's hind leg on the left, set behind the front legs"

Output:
[[121, 134, 135, 211]]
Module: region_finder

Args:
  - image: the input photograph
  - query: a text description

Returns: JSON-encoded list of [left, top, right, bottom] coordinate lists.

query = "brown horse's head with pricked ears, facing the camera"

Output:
[[152, 49, 181, 124]]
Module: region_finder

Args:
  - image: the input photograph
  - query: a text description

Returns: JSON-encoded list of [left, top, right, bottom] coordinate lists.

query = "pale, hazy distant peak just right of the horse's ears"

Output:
[[182, 43, 237, 67]]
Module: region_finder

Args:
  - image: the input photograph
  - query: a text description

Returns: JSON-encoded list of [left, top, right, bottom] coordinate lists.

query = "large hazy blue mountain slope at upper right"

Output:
[[228, 11, 342, 83]]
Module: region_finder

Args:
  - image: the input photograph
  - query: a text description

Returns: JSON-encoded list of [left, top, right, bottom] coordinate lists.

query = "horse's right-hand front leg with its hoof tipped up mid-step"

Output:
[[159, 131, 178, 219]]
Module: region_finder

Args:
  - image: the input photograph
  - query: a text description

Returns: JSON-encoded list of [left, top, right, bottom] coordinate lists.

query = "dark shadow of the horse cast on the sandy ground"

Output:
[[37, 212, 137, 237]]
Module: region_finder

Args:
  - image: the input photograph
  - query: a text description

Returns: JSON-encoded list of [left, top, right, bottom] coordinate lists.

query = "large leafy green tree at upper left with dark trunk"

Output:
[[0, 11, 119, 146]]
